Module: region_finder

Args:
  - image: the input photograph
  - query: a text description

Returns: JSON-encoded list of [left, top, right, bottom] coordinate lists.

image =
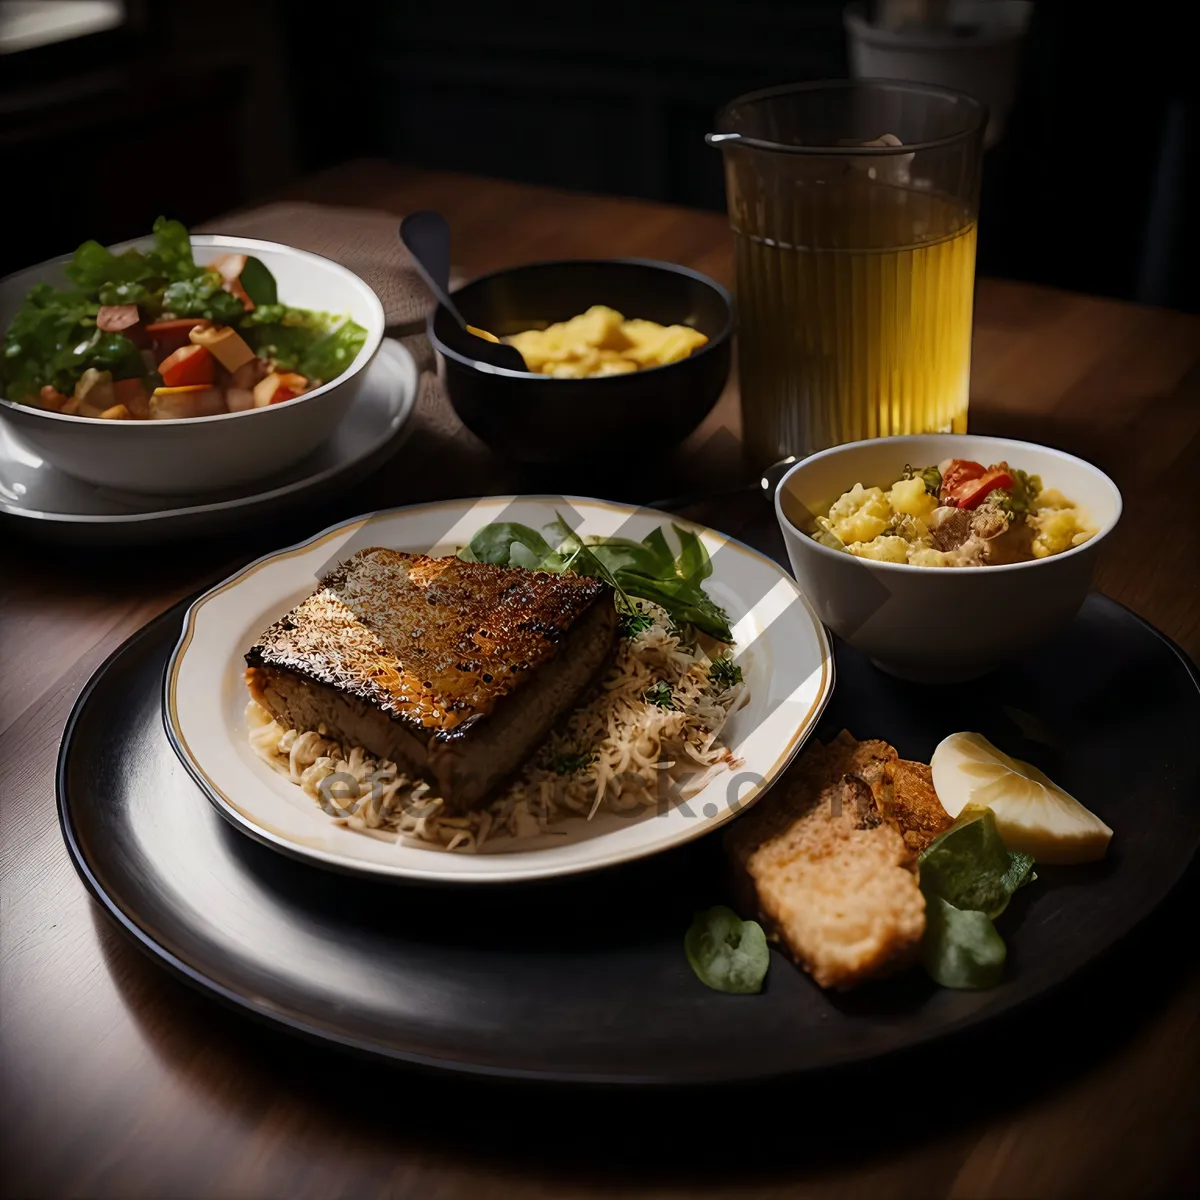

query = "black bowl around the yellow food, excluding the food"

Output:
[[428, 258, 733, 463]]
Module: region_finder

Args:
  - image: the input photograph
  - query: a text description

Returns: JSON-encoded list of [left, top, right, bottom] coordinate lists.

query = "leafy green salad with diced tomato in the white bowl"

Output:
[[0, 217, 367, 420]]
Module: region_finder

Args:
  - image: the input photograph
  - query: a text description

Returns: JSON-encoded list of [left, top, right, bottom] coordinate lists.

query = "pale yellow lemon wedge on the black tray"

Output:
[[930, 733, 1112, 864]]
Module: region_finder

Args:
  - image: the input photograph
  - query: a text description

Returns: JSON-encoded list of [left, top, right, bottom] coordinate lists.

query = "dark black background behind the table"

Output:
[[0, 0, 1200, 310]]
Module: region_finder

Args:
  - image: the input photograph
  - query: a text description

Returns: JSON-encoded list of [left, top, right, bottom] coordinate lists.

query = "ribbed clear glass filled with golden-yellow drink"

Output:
[[708, 80, 988, 466]]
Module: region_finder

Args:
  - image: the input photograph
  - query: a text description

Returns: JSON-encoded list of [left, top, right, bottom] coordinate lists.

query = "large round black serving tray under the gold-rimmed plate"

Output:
[[58, 595, 1200, 1085]]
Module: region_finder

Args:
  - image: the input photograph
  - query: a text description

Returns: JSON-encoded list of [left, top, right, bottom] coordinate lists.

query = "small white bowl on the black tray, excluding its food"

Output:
[[775, 433, 1121, 683]]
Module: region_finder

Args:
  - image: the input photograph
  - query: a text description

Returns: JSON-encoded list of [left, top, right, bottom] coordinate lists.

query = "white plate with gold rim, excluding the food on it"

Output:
[[163, 497, 834, 883]]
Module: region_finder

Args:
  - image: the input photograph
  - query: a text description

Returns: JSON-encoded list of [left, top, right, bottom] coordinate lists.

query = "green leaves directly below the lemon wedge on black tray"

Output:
[[919, 805, 1037, 988]]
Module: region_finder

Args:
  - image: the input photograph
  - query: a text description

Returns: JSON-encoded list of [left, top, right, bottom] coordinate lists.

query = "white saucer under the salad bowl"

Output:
[[0, 338, 418, 546]]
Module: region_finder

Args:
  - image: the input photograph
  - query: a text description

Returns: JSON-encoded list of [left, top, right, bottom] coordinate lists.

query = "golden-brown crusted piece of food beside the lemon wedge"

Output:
[[725, 733, 925, 988]]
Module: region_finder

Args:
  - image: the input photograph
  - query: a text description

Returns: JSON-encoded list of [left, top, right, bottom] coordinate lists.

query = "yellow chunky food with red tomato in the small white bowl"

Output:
[[812, 458, 1096, 566]]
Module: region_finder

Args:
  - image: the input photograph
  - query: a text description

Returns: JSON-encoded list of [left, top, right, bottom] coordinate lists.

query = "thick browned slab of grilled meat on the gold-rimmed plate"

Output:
[[246, 547, 617, 812]]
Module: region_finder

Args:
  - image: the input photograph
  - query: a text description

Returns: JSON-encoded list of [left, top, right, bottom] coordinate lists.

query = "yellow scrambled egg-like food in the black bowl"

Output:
[[499, 305, 708, 379]]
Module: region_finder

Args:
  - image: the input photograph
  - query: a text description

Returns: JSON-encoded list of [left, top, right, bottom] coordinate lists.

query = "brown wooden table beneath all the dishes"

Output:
[[0, 162, 1200, 1200]]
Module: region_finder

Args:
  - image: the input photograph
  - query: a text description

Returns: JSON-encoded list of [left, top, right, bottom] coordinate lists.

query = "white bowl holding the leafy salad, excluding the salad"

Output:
[[0, 234, 384, 496]]
